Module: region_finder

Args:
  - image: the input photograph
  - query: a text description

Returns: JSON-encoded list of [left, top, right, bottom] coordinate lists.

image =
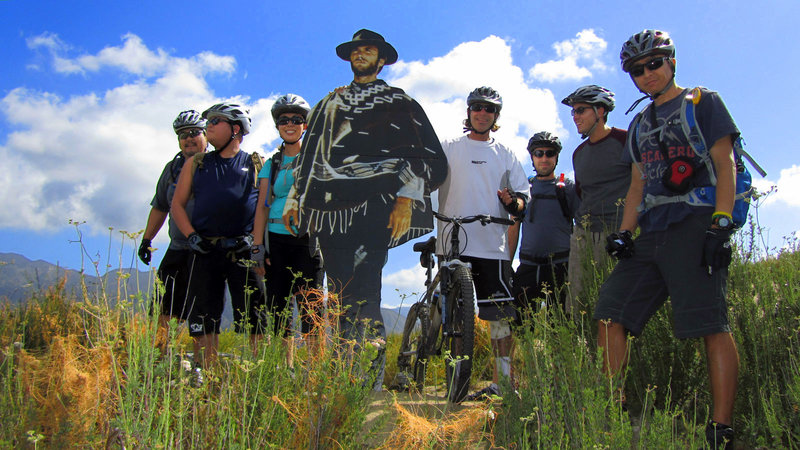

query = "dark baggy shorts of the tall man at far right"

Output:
[[594, 214, 731, 338]]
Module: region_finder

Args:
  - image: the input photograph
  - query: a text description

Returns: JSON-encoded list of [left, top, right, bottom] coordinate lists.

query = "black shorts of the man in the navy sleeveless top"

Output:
[[188, 251, 268, 336]]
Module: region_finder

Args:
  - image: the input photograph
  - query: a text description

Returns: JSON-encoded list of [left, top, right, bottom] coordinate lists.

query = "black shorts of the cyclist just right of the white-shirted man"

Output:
[[512, 261, 569, 319]]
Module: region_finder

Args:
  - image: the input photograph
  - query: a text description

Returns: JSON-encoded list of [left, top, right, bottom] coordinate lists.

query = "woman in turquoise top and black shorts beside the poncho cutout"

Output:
[[252, 94, 323, 367]]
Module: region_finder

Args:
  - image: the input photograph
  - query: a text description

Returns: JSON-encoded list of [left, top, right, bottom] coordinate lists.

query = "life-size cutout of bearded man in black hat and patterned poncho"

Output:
[[283, 29, 447, 390]]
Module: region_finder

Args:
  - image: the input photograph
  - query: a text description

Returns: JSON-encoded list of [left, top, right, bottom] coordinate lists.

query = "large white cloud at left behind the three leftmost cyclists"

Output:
[[0, 33, 277, 240]]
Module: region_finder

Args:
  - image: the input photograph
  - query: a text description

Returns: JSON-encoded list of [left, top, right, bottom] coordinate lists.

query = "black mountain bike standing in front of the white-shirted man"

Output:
[[397, 211, 514, 403]]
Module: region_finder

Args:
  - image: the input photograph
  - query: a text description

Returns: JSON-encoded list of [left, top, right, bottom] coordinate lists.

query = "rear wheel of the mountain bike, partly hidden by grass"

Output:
[[397, 302, 431, 391]]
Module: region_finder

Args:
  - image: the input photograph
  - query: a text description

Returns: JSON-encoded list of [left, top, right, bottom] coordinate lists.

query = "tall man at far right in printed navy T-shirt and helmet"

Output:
[[594, 30, 739, 448]]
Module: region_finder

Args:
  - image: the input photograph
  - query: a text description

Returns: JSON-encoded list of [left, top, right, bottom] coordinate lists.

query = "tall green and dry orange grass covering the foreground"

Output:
[[0, 220, 800, 448]]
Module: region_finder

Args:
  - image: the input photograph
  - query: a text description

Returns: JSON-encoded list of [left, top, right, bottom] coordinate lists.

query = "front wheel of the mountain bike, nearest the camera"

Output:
[[445, 266, 475, 403]]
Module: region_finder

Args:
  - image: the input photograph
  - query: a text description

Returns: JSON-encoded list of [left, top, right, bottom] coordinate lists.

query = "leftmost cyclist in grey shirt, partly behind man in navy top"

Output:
[[138, 109, 208, 349]]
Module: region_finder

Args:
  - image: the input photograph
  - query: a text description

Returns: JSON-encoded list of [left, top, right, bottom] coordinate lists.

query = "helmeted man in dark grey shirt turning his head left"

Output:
[[561, 84, 631, 312]]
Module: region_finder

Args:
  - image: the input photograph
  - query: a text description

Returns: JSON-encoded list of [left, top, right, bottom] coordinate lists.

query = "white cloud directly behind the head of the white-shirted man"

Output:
[[387, 36, 567, 166]]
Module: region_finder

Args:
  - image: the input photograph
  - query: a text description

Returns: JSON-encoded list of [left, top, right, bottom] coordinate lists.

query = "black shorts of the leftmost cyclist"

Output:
[[152, 249, 192, 320]]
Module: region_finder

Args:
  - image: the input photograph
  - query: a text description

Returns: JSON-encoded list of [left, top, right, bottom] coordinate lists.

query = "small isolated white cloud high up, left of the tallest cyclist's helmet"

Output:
[[528, 28, 608, 83]]
